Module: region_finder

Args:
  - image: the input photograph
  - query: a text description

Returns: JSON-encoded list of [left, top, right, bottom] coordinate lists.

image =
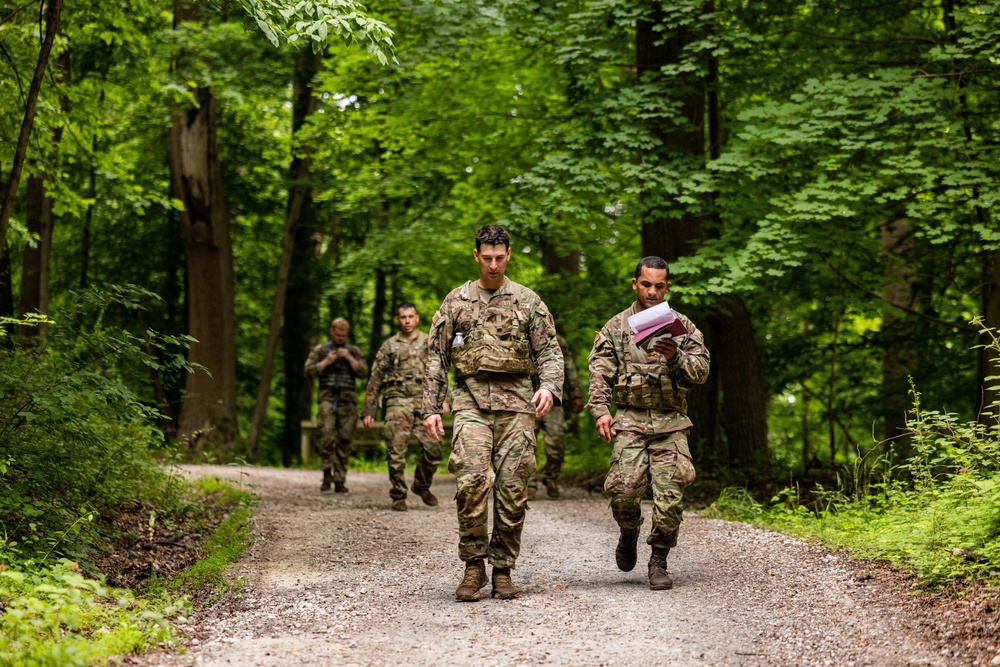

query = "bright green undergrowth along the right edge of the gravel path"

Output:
[[711, 332, 1000, 585]]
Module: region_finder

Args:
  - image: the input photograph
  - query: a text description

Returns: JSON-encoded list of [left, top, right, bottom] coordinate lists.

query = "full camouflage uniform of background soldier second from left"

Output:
[[361, 330, 441, 500]]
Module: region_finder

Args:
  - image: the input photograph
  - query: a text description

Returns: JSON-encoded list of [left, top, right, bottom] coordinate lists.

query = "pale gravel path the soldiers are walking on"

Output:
[[125, 466, 1000, 667]]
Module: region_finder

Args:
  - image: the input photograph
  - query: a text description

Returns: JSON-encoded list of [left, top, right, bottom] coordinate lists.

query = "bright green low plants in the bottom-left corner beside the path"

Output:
[[0, 560, 183, 667]]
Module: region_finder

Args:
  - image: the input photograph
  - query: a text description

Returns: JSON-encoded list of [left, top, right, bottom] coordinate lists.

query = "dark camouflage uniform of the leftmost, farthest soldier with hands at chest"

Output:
[[305, 342, 368, 484]]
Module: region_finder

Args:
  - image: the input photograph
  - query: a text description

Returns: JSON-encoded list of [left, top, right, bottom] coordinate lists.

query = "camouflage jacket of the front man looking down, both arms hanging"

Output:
[[421, 278, 564, 417]]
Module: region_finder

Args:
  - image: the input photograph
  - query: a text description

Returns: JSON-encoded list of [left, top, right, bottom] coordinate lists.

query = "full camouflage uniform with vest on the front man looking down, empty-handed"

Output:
[[422, 278, 563, 568]]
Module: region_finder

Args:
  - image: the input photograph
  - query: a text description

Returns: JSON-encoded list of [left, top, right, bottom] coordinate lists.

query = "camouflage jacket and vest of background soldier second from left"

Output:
[[361, 329, 429, 417]]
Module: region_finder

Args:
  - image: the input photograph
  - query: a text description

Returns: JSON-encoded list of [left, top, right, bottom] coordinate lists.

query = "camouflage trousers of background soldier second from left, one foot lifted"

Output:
[[382, 400, 441, 500]]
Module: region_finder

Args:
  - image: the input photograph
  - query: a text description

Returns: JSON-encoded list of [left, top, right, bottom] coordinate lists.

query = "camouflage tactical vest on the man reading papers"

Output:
[[615, 316, 688, 414]]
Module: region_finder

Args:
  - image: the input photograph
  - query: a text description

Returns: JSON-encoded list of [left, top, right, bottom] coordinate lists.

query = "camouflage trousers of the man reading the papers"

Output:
[[604, 430, 695, 549]]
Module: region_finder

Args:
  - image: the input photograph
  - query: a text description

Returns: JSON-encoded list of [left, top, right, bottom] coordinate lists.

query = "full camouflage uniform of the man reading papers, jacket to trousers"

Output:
[[587, 304, 709, 549]]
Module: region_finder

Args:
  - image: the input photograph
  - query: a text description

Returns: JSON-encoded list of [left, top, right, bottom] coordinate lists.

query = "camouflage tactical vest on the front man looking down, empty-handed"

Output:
[[451, 281, 531, 378]]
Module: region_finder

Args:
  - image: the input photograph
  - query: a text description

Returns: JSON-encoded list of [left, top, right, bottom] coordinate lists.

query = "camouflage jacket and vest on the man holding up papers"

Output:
[[587, 303, 709, 434]]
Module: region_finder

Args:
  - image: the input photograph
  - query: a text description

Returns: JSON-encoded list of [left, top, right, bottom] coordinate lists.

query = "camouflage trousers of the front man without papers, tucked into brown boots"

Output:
[[448, 408, 535, 568]]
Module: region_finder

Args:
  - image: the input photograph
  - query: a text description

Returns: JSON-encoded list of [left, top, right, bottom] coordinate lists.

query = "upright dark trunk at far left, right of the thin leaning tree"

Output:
[[18, 176, 52, 337]]
